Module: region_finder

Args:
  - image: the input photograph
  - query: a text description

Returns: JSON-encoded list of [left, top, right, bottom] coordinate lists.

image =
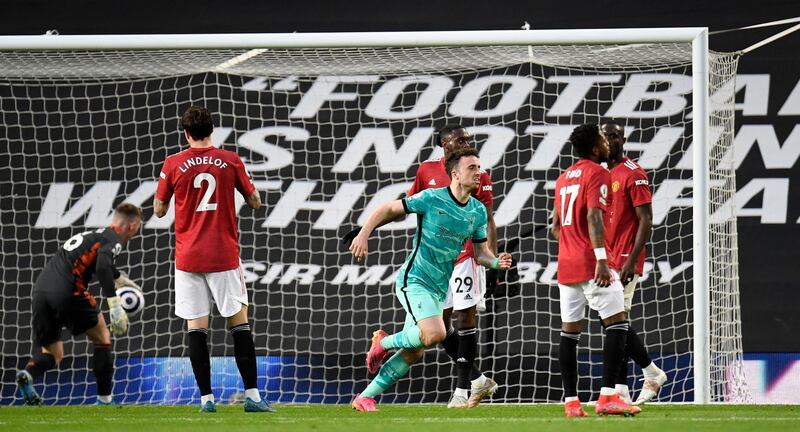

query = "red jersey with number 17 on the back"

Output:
[[555, 159, 611, 284]]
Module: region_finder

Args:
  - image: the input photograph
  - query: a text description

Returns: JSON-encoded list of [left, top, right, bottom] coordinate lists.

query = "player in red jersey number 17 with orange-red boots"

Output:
[[552, 124, 640, 417]]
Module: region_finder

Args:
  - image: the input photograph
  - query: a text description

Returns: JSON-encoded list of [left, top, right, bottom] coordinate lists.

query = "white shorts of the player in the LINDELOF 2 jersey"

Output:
[[175, 266, 247, 320]]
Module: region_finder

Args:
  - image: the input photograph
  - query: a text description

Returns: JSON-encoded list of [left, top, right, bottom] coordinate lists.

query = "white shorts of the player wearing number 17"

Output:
[[558, 270, 625, 322]]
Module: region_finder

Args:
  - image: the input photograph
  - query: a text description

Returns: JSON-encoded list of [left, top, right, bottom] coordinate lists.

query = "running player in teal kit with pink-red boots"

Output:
[[350, 148, 511, 411]]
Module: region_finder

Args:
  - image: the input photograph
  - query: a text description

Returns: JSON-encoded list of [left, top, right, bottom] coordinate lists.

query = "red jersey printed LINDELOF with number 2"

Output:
[[156, 147, 256, 273]]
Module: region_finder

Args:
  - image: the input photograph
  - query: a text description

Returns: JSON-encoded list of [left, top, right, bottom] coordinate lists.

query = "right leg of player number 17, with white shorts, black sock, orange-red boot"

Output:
[[584, 272, 640, 415]]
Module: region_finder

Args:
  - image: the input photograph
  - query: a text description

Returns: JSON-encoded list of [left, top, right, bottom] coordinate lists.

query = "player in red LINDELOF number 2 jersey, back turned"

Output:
[[153, 106, 273, 412]]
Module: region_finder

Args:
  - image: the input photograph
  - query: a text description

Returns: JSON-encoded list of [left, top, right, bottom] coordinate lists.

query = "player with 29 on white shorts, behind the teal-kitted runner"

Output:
[[407, 124, 498, 408]]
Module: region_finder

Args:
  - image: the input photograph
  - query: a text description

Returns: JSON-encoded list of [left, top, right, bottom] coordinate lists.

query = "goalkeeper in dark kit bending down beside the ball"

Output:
[[16, 203, 142, 405]]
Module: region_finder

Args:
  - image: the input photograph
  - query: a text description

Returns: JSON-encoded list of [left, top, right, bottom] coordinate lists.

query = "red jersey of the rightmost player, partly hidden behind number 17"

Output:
[[606, 157, 653, 274]]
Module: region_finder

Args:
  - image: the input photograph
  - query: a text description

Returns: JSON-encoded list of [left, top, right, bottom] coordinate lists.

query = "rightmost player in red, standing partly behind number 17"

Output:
[[601, 121, 667, 405]]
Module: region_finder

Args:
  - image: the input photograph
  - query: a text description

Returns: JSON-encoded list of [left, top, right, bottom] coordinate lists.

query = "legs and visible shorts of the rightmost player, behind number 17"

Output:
[[618, 274, 667, 405]]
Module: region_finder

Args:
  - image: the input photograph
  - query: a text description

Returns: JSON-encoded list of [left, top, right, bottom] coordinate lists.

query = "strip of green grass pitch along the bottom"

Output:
[[0, 405, 800, 432]]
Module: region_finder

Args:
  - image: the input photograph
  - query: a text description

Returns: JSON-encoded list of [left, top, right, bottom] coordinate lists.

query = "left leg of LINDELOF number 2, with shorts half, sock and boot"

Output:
[[175, 269, 217, 412]]
